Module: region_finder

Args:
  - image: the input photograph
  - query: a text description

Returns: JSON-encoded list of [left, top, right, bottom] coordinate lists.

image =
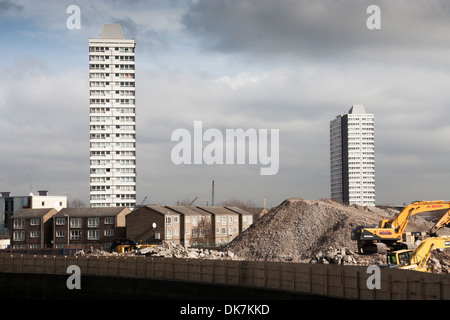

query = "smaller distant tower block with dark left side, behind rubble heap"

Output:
[[330, 104, 375, 206]]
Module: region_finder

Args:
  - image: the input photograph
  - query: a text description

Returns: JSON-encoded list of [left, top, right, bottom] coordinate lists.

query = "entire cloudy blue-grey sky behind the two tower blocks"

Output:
[[0, 0, 450, 207]]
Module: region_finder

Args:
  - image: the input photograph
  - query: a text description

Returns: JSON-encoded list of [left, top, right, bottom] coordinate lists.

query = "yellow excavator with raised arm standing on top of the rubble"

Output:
[[351, 200, 450, 254]]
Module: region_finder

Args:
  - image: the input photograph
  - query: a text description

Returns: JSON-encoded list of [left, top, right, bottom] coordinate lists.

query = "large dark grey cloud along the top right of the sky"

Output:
[[183, 0, 450, 59]]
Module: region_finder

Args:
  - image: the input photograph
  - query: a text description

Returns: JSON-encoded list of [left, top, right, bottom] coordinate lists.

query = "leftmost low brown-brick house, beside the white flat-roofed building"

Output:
[[10, 209, 58, 249]]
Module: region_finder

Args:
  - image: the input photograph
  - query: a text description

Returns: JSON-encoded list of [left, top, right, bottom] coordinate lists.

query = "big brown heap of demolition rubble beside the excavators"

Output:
[[228, 198, 450, 272]]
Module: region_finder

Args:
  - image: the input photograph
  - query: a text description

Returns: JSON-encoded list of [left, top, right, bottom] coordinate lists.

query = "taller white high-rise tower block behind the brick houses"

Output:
[[89, 24, 136, 208]]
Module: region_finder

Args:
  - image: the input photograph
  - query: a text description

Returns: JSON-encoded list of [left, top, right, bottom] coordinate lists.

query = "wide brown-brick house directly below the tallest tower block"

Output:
[[53, 207, 131, 249]]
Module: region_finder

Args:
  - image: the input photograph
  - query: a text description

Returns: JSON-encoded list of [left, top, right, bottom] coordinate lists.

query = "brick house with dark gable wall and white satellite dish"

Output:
[[126, 206, 181, 244]]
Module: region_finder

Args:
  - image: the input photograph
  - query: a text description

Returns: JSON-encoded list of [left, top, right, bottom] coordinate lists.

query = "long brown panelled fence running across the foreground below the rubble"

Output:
[[0, 253, 450, 300]]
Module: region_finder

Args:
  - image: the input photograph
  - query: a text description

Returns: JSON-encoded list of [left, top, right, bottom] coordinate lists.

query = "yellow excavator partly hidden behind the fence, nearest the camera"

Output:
[[380, 236, 450, 272]]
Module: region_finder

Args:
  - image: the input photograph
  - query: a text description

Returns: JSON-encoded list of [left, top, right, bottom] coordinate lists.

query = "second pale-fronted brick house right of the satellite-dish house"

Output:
[[197, 206, 239, 246]]
